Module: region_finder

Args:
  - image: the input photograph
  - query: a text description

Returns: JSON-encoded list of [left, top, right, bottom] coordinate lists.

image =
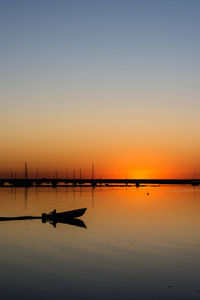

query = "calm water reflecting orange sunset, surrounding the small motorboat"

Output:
[[0, 186, 200, 300]]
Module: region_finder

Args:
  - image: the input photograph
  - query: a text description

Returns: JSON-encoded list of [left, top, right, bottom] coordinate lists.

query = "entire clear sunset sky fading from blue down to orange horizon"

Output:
[[0, 0, 200, 178]]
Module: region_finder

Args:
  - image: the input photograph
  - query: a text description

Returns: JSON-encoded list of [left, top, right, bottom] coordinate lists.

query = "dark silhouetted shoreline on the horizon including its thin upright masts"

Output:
[[0, 162, 200, 188]]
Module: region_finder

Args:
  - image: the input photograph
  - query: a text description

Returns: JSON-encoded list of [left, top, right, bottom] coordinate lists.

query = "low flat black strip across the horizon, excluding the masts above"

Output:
[[0, 178, 200, 187]]
